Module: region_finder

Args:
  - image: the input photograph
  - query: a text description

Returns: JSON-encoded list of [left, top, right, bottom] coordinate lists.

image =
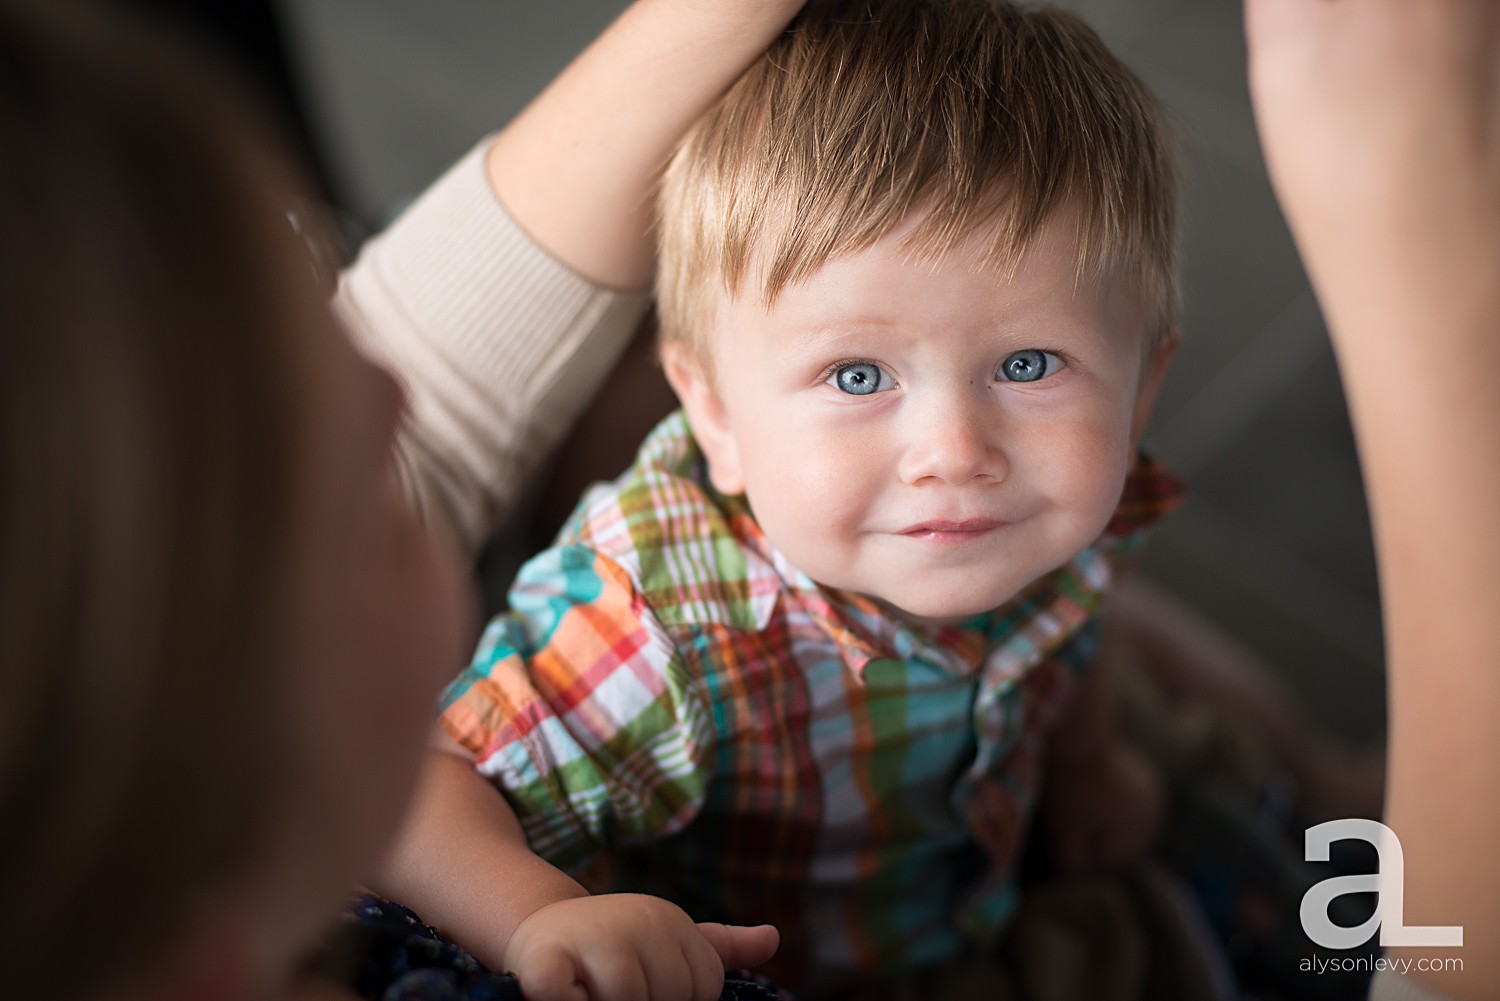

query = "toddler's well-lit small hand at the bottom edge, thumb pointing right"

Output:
[[506, 893, 780, 1001]]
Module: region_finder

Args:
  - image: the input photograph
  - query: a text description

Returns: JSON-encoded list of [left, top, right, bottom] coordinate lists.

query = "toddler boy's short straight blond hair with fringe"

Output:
[[657, 0, 1178, 357]]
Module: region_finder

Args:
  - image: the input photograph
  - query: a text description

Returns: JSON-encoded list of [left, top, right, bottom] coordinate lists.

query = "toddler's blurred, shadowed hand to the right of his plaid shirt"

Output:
[[1041, 740, 1166, 875]]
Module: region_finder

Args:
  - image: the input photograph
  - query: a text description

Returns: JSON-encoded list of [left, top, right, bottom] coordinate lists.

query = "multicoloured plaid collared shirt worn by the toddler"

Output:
[[443, 414, 1179, 986]]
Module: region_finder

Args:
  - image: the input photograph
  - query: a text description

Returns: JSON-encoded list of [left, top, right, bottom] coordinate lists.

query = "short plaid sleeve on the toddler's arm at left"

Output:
[[441, 545, 713, 869]]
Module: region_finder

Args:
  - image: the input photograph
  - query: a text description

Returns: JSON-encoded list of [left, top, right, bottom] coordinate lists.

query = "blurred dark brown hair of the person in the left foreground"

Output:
[[0, 3, 313, 998]]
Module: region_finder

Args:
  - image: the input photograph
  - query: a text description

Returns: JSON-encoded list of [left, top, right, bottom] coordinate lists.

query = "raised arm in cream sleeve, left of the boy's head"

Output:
[[327, 0, 801, 554]]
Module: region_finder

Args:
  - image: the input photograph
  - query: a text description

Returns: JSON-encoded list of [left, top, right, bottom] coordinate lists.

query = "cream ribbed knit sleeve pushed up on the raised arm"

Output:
[[335, 140, 647, 555]]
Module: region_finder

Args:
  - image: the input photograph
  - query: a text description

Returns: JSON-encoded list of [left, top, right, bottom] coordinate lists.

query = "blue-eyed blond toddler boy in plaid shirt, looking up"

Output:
[[419, 0, 1176, 996]]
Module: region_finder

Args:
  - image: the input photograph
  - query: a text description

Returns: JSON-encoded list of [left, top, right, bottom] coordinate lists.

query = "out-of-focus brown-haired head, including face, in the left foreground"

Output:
[[0, 3, 461, 998]]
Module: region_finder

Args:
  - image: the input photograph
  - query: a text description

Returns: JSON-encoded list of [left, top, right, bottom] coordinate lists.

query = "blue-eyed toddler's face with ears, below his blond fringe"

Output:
[[668, 210, 1170, 620]]
